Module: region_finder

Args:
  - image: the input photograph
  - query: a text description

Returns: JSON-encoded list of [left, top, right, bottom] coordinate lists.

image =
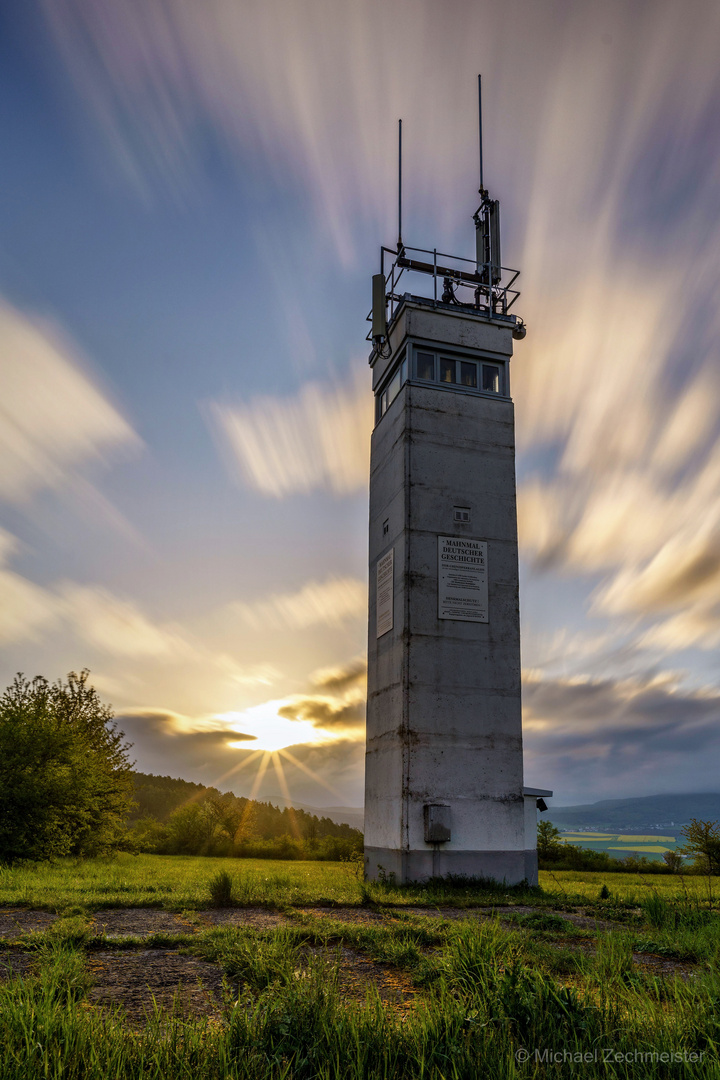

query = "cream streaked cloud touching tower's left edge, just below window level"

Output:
[[207, 364, 372, 498]]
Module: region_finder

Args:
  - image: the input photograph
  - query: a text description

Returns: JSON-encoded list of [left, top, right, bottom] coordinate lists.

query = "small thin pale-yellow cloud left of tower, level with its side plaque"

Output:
[[226, 578, 367, 630]]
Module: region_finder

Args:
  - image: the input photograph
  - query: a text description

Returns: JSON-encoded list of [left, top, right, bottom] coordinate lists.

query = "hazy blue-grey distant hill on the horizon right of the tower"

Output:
[[543, 792, 720, 833]]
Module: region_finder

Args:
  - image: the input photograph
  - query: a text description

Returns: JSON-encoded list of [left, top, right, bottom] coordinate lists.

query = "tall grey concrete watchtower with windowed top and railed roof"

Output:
[[365, 95, 552, 883]]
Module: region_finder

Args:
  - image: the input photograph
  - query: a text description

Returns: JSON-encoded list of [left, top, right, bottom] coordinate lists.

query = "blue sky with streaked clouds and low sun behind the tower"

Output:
[[0, 0, 720, 806]]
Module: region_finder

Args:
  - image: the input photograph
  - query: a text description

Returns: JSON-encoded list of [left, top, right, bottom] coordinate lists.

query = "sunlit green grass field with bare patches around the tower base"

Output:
[[0, 855, 720, 1080]]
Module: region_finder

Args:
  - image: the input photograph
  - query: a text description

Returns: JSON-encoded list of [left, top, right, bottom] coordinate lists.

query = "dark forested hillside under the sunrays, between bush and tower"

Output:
[[127, 772, 363, 860]]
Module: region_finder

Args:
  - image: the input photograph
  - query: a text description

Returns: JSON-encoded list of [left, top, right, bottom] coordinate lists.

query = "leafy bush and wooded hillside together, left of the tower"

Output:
[[0, 671, 363, 863]]
